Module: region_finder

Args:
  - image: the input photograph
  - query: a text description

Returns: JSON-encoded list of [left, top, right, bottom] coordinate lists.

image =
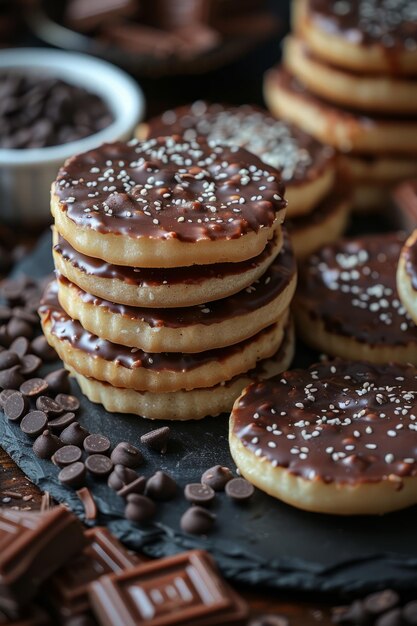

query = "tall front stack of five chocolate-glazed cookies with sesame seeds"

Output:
[[40, 135, 296, 420]]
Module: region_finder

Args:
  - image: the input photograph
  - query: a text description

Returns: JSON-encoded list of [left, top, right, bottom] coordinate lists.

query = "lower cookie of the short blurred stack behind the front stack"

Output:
[[286, 189, 352, 259]]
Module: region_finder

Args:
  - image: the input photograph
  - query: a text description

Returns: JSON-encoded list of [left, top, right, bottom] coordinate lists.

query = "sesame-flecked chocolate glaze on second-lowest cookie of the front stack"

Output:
[[39, 281, 278, 372]]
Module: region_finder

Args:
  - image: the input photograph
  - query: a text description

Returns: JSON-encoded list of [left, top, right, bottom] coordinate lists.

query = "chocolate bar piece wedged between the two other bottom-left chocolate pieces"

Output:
[[45, 527, 142, 621]]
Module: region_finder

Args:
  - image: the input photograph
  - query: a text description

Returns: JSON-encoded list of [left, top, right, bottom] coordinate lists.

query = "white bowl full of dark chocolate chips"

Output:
[[0, 48, 145, 224]]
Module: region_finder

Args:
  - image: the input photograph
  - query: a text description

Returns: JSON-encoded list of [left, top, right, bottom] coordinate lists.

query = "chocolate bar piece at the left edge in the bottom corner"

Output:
[[0, 506, 86, 617]]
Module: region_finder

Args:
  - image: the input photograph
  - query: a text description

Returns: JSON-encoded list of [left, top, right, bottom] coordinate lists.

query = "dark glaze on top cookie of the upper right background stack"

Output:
[[308, 0, 417, 52]]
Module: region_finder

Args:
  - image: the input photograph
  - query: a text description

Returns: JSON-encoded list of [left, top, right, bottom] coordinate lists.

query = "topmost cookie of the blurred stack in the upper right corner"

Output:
[[293, 0, 417, 75]]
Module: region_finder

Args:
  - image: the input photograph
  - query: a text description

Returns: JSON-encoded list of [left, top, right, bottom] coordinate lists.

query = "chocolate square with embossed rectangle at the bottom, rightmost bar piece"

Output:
[[90, 550, 248, 626]]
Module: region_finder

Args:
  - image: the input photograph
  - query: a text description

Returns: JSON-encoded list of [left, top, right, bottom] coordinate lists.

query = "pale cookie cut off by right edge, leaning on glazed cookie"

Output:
[[397, 229, 417, 324]]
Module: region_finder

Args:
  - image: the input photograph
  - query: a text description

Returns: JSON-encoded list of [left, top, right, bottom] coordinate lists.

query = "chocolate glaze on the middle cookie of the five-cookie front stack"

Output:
[[58, 230, 297, 328]]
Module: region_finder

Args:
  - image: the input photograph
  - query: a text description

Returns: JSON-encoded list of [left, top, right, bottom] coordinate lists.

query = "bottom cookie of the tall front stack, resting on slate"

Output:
[[68, 324, 295, 421]]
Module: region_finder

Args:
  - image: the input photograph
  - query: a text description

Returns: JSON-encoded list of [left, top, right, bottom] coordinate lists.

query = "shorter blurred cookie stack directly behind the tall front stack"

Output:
[[137, 101, 350, 257]]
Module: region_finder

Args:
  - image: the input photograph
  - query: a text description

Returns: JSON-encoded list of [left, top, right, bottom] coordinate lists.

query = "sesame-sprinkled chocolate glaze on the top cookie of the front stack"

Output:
[[54, 136, 286, 242]]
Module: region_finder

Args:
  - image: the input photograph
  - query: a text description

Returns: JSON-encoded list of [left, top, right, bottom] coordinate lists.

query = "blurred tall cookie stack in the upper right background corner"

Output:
[[265, 0, 417, 210]]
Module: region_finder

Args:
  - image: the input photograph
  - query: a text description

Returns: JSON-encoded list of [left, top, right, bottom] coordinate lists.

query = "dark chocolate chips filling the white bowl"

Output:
[[0, 71, 113, 149]]
